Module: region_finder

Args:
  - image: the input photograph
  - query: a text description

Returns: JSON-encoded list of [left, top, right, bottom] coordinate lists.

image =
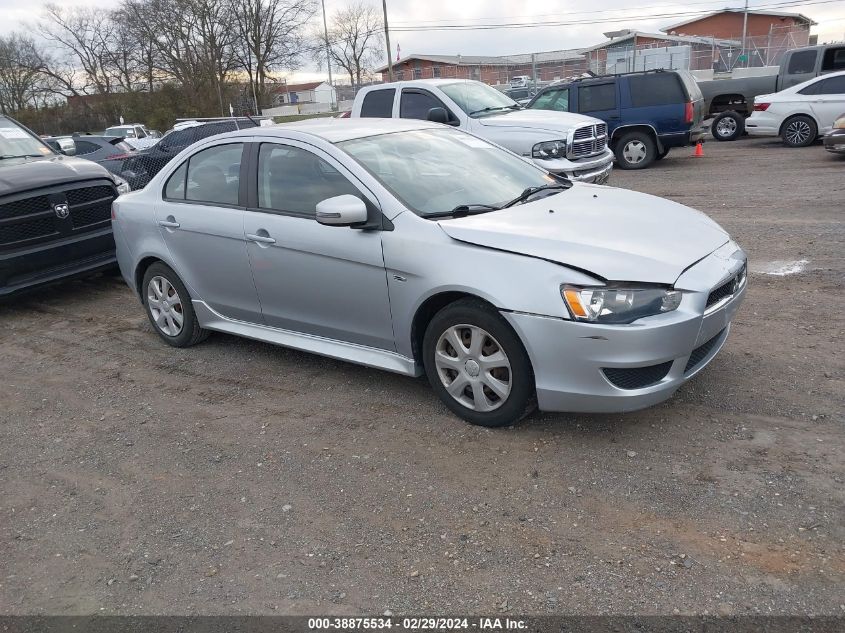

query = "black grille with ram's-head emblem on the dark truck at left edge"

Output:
[[0, 181, 117, 248]]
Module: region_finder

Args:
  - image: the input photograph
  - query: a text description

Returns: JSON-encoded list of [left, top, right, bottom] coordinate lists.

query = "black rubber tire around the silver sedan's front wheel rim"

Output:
[[422, 299, 537, 427]]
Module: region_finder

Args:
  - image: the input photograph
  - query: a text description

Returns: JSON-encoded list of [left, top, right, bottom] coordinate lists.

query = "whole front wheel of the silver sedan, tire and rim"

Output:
[[422, 299, 536, 427]]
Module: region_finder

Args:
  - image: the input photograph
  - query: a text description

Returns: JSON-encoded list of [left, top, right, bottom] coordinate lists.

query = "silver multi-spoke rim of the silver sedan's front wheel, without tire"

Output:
[[434, 324, 512, 412]]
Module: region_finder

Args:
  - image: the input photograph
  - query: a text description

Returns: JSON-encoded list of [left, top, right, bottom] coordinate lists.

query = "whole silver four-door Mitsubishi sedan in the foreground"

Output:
[[113, 119, 746, 426]]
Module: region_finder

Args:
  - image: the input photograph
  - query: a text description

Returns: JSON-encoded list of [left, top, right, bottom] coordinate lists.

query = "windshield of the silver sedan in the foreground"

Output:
[[338, 128, 555, 217]]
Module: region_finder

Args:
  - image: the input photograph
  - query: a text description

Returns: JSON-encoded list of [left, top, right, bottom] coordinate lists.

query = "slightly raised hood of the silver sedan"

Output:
[[439, 184, 730, 284]]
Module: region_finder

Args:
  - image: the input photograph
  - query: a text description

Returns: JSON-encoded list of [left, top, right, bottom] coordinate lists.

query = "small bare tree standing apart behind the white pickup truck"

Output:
[[320, 0, 384, 87]]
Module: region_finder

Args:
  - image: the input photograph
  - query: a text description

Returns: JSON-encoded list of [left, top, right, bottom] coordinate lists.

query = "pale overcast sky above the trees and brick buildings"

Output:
[[0, 0, 845, 80]]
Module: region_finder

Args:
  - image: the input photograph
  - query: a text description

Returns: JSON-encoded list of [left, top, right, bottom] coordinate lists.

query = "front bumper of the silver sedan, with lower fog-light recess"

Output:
[[503, 243, 747, 413]]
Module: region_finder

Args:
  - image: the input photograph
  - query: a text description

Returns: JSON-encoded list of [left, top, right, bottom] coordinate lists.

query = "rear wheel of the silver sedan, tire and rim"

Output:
[[141, 262, 210, 347]]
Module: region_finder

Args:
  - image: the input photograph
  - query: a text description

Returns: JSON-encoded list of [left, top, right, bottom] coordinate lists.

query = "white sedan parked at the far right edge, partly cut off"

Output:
[[745, 71, 845, 147]]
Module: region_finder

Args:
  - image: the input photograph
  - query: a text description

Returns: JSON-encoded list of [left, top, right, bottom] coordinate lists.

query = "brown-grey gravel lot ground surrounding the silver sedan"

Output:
[[0, 139, 845, 614]]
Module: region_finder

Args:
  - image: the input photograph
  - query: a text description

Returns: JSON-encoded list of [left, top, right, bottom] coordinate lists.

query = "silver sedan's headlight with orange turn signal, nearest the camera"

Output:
[[560, 286, 682, 323]]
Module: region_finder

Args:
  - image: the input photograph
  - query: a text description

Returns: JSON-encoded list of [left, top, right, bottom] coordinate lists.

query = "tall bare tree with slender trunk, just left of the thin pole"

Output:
[[231, 0, 317, 114]]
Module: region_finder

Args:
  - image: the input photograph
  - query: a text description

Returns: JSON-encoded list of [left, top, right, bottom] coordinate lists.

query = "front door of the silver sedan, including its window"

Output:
[[244, 141, 395, 350]]
